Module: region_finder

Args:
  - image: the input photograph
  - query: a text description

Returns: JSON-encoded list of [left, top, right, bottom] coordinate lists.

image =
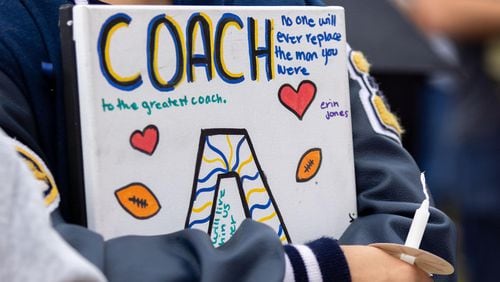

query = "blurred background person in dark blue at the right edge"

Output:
[[396, 0, 500, 281]]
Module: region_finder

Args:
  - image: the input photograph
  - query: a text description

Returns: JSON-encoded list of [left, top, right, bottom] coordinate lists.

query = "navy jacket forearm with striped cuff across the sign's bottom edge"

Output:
[[53, 214, 350, 282]]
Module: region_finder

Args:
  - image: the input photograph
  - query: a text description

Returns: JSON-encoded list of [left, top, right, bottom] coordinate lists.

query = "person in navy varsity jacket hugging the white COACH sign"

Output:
[[0, 0, 455, 281]]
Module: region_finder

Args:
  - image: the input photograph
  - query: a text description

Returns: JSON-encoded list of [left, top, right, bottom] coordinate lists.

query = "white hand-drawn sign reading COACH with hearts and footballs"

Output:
[[71, 6, 356, 243]]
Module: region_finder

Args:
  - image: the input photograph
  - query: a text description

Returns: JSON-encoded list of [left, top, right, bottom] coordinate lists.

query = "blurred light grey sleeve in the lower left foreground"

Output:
[[0, 128, 105, 282]]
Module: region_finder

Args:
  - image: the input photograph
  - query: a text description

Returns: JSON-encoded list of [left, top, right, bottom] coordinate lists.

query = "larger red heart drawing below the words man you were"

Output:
[[278, 80, 316, 120]]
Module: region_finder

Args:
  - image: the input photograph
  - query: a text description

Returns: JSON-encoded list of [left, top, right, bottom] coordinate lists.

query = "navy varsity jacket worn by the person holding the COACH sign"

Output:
[[0, 0, 456, 281]]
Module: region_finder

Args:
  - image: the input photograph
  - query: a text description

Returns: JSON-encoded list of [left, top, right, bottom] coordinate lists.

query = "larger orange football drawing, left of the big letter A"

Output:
[[115, 183, 161, 219]]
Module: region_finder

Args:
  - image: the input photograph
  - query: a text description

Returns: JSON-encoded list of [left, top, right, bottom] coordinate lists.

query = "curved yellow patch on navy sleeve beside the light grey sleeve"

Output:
[[14, 140, 59, 211]]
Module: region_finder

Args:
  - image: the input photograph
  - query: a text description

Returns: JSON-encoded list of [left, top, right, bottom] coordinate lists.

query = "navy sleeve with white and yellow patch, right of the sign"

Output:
[[339, 48, 456, 280]]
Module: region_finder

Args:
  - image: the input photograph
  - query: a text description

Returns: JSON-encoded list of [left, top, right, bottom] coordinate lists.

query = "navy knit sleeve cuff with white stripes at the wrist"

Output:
[[284, 238, 351, 282]]
